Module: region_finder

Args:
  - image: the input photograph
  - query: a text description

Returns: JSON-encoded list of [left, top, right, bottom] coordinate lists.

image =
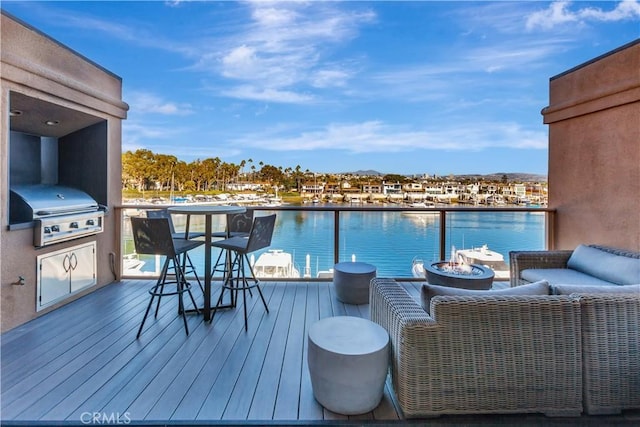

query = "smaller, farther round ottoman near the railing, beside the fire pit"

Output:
[[333, 262, 376, 304]]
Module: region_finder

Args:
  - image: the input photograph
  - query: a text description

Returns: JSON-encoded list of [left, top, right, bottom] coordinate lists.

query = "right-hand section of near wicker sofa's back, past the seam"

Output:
[[580, 294, 640, 414]]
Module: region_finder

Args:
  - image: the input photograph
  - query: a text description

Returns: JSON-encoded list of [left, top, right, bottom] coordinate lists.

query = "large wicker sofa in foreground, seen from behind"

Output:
[[370, 278, 640, 418]]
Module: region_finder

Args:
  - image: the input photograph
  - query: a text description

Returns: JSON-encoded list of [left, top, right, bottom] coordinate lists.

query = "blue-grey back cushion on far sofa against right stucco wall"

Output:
[[567, 245, 640, 285]]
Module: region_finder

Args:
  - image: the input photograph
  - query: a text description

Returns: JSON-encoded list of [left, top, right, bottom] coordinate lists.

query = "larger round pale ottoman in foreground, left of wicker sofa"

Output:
[[307, 316, 389, 415]]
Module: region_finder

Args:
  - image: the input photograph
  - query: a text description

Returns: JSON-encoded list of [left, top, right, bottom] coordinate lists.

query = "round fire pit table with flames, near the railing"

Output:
[[424, 261, 494, 289]]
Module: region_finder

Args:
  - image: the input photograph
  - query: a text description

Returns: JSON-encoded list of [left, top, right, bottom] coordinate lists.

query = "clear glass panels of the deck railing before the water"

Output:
[[122, 207, 547, 280]]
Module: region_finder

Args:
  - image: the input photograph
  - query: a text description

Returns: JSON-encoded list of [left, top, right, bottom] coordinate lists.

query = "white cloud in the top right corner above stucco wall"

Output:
[[526, 0, 640, 30]]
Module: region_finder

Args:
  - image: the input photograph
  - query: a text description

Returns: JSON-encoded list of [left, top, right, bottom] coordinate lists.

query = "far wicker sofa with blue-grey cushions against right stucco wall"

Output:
[[509, 245, 640, 287]]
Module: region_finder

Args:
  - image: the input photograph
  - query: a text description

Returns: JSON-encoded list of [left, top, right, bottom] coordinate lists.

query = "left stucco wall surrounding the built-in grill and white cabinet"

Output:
[[0, 12, 128, 331]]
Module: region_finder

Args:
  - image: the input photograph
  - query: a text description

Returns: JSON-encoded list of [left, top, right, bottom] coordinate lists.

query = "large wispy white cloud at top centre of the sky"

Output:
[[212, 1, 375, 103]]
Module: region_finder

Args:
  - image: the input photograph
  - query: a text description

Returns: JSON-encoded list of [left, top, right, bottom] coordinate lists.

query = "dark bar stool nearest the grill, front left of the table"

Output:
[[131, 217, 204, 339]]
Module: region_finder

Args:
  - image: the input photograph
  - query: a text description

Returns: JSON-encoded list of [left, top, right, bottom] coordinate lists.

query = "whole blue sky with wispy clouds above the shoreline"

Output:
[[2, 0, 640, 175]]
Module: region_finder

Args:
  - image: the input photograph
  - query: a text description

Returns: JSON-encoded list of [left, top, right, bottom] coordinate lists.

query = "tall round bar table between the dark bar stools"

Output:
[[168, 205, 246, 321]]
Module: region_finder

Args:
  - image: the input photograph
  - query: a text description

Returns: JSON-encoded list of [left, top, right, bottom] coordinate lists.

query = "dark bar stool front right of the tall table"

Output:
[[211, 214, 276, 331]]
